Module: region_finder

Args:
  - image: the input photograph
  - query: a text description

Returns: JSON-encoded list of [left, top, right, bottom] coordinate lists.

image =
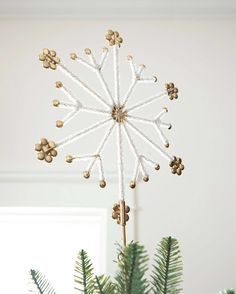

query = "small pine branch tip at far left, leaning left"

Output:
[[30, 269, 56, 294]]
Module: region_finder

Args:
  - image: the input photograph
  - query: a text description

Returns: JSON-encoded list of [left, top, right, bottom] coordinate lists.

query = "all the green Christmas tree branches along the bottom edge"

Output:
[[30, 237, 184, 294]]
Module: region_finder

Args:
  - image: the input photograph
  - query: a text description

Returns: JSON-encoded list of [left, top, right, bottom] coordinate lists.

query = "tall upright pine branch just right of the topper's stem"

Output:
[[152, 237, 182, 294]]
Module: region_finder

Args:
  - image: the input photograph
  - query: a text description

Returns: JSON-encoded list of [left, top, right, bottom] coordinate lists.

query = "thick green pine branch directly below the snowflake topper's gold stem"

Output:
[[115, 243, 149, 294]]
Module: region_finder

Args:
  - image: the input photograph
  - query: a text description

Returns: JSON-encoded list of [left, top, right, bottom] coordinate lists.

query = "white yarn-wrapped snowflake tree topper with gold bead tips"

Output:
[[35, 30, 184, 245]]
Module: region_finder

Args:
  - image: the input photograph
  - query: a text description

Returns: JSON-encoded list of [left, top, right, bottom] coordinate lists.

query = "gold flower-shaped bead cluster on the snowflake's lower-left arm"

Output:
[[35, 138, 57, 163]]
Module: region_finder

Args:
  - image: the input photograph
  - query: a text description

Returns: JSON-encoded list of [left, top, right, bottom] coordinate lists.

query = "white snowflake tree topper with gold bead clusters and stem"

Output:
[[35, 30, 184, 250]]
